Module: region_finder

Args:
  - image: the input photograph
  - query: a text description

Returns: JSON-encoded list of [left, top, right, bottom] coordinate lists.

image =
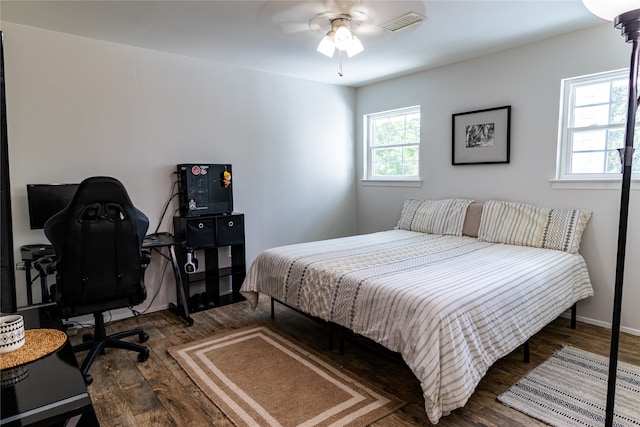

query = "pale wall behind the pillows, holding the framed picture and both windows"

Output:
[[356, 24, 640, 333]]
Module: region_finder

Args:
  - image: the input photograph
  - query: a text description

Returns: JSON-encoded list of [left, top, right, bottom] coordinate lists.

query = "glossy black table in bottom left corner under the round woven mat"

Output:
[[0, 304, 99, 427]]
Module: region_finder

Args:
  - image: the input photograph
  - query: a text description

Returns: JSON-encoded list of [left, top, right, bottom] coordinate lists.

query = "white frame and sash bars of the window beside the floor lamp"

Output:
[[553, 68, 640, 183]]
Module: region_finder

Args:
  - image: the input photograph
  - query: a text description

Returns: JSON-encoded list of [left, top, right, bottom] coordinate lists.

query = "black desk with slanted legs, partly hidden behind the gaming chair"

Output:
[[20, 232, 193, 326]]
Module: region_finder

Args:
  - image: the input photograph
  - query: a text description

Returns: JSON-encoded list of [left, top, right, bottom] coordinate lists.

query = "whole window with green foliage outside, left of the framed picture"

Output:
[[364, 105, 420, 181]]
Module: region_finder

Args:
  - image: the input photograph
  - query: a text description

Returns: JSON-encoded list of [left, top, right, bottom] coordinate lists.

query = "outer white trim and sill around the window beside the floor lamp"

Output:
[[550, 68, 640, 186]]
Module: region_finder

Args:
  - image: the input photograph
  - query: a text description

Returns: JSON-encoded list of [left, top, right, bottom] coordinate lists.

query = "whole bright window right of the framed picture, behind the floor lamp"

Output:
[[557, 70, 640, 179]]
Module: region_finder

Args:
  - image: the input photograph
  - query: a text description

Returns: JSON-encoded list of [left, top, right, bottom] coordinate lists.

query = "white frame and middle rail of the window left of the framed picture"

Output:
[[362, 105, 422, 185]]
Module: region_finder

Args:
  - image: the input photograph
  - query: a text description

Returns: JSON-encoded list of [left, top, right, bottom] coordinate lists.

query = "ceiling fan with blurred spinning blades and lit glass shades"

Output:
[[261, 0, 426, 76]]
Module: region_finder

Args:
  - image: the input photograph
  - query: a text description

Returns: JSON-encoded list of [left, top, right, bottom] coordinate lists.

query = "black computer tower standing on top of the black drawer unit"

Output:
[[177, 163, 233, 217]]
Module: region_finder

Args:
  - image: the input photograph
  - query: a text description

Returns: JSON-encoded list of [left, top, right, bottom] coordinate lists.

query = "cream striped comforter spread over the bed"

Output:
[[241, 230, 593, 423]]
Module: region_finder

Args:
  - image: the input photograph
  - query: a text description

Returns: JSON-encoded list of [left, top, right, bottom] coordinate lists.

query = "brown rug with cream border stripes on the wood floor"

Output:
[[168, 326, 404, 426]]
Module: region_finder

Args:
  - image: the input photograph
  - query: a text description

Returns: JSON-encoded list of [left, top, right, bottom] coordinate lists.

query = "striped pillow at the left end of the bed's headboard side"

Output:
[[396, 198, 473, 236]]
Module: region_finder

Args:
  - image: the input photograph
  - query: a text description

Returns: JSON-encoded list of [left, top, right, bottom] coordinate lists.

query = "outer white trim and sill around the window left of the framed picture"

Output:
[[361, 105, 422, 187]]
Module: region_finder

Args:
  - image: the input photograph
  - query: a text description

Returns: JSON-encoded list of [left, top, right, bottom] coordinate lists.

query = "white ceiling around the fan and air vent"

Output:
[[0, 0, 603, 87]]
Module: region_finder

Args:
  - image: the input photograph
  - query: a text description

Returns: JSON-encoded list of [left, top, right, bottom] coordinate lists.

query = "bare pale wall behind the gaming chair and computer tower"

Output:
[[1, 22, 355, 316]]
